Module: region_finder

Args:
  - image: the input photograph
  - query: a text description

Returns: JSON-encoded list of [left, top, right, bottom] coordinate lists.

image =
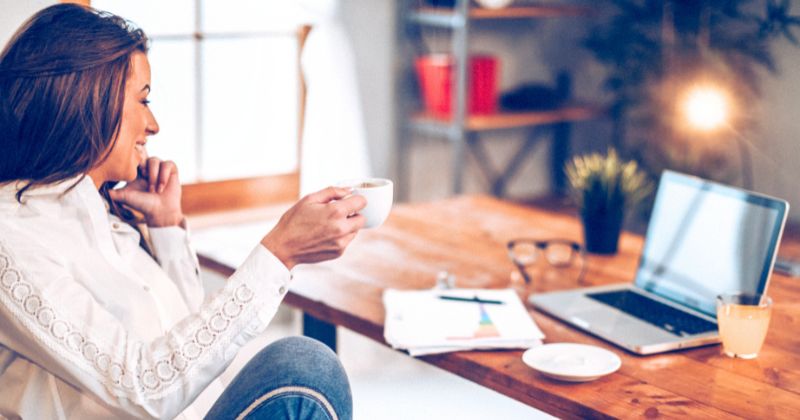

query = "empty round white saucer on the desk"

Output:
[[522, 343, 622, 382]]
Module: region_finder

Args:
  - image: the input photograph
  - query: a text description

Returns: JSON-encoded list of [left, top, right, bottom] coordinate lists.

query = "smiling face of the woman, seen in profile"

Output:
[[89, 51, 158, 188]]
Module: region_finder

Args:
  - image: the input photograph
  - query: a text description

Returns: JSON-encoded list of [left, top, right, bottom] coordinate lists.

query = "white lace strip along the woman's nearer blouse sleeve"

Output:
[[0, 242, 254, 396]]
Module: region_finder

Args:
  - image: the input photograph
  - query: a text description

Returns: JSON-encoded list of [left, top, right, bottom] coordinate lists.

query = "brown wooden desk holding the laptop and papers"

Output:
[[192, 196, 800, 419]]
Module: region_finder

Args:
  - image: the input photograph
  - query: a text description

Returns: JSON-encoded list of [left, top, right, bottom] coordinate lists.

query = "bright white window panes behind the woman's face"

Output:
[[91, 0, 302, 183]]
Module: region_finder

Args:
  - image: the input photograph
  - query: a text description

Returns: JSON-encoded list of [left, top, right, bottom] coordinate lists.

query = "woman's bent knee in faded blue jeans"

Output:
[[206, 337, 353, 420]]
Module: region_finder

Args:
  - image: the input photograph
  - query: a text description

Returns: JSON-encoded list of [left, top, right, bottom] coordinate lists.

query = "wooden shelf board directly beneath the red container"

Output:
[[413, 105, 604, 131]]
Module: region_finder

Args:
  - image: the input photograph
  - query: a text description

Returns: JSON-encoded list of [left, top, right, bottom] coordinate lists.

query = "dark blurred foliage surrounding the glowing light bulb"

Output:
[[585, 0, 800, 182]]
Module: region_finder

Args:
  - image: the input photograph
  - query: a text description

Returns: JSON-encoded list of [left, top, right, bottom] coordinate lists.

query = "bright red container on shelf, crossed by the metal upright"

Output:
[[414, 54, 498, 118]]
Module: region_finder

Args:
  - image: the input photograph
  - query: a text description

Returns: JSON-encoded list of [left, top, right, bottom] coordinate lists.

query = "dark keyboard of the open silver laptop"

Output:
[[587, 290, 717, 336]]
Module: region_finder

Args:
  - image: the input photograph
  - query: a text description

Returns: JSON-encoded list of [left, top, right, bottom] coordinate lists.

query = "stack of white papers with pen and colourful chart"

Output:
[[383, 289, 544, 356]]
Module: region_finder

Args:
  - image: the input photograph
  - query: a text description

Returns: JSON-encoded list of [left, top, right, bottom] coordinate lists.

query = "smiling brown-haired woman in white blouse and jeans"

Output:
[[0, 4, 366, 419]]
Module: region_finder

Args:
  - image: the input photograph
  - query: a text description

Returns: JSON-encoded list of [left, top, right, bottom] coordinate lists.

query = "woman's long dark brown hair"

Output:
[[0, 4, 148, 250]]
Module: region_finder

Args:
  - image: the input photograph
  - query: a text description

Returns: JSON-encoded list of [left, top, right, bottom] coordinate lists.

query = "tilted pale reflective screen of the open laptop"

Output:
[[636, 171, 788, 317]]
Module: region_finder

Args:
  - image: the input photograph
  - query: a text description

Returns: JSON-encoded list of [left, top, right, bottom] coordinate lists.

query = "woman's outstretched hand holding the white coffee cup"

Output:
[[261, 187, 367, 270]]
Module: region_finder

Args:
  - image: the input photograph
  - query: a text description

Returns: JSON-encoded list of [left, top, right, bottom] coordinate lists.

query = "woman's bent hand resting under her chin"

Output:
[[109, 157, 183, 227]]
